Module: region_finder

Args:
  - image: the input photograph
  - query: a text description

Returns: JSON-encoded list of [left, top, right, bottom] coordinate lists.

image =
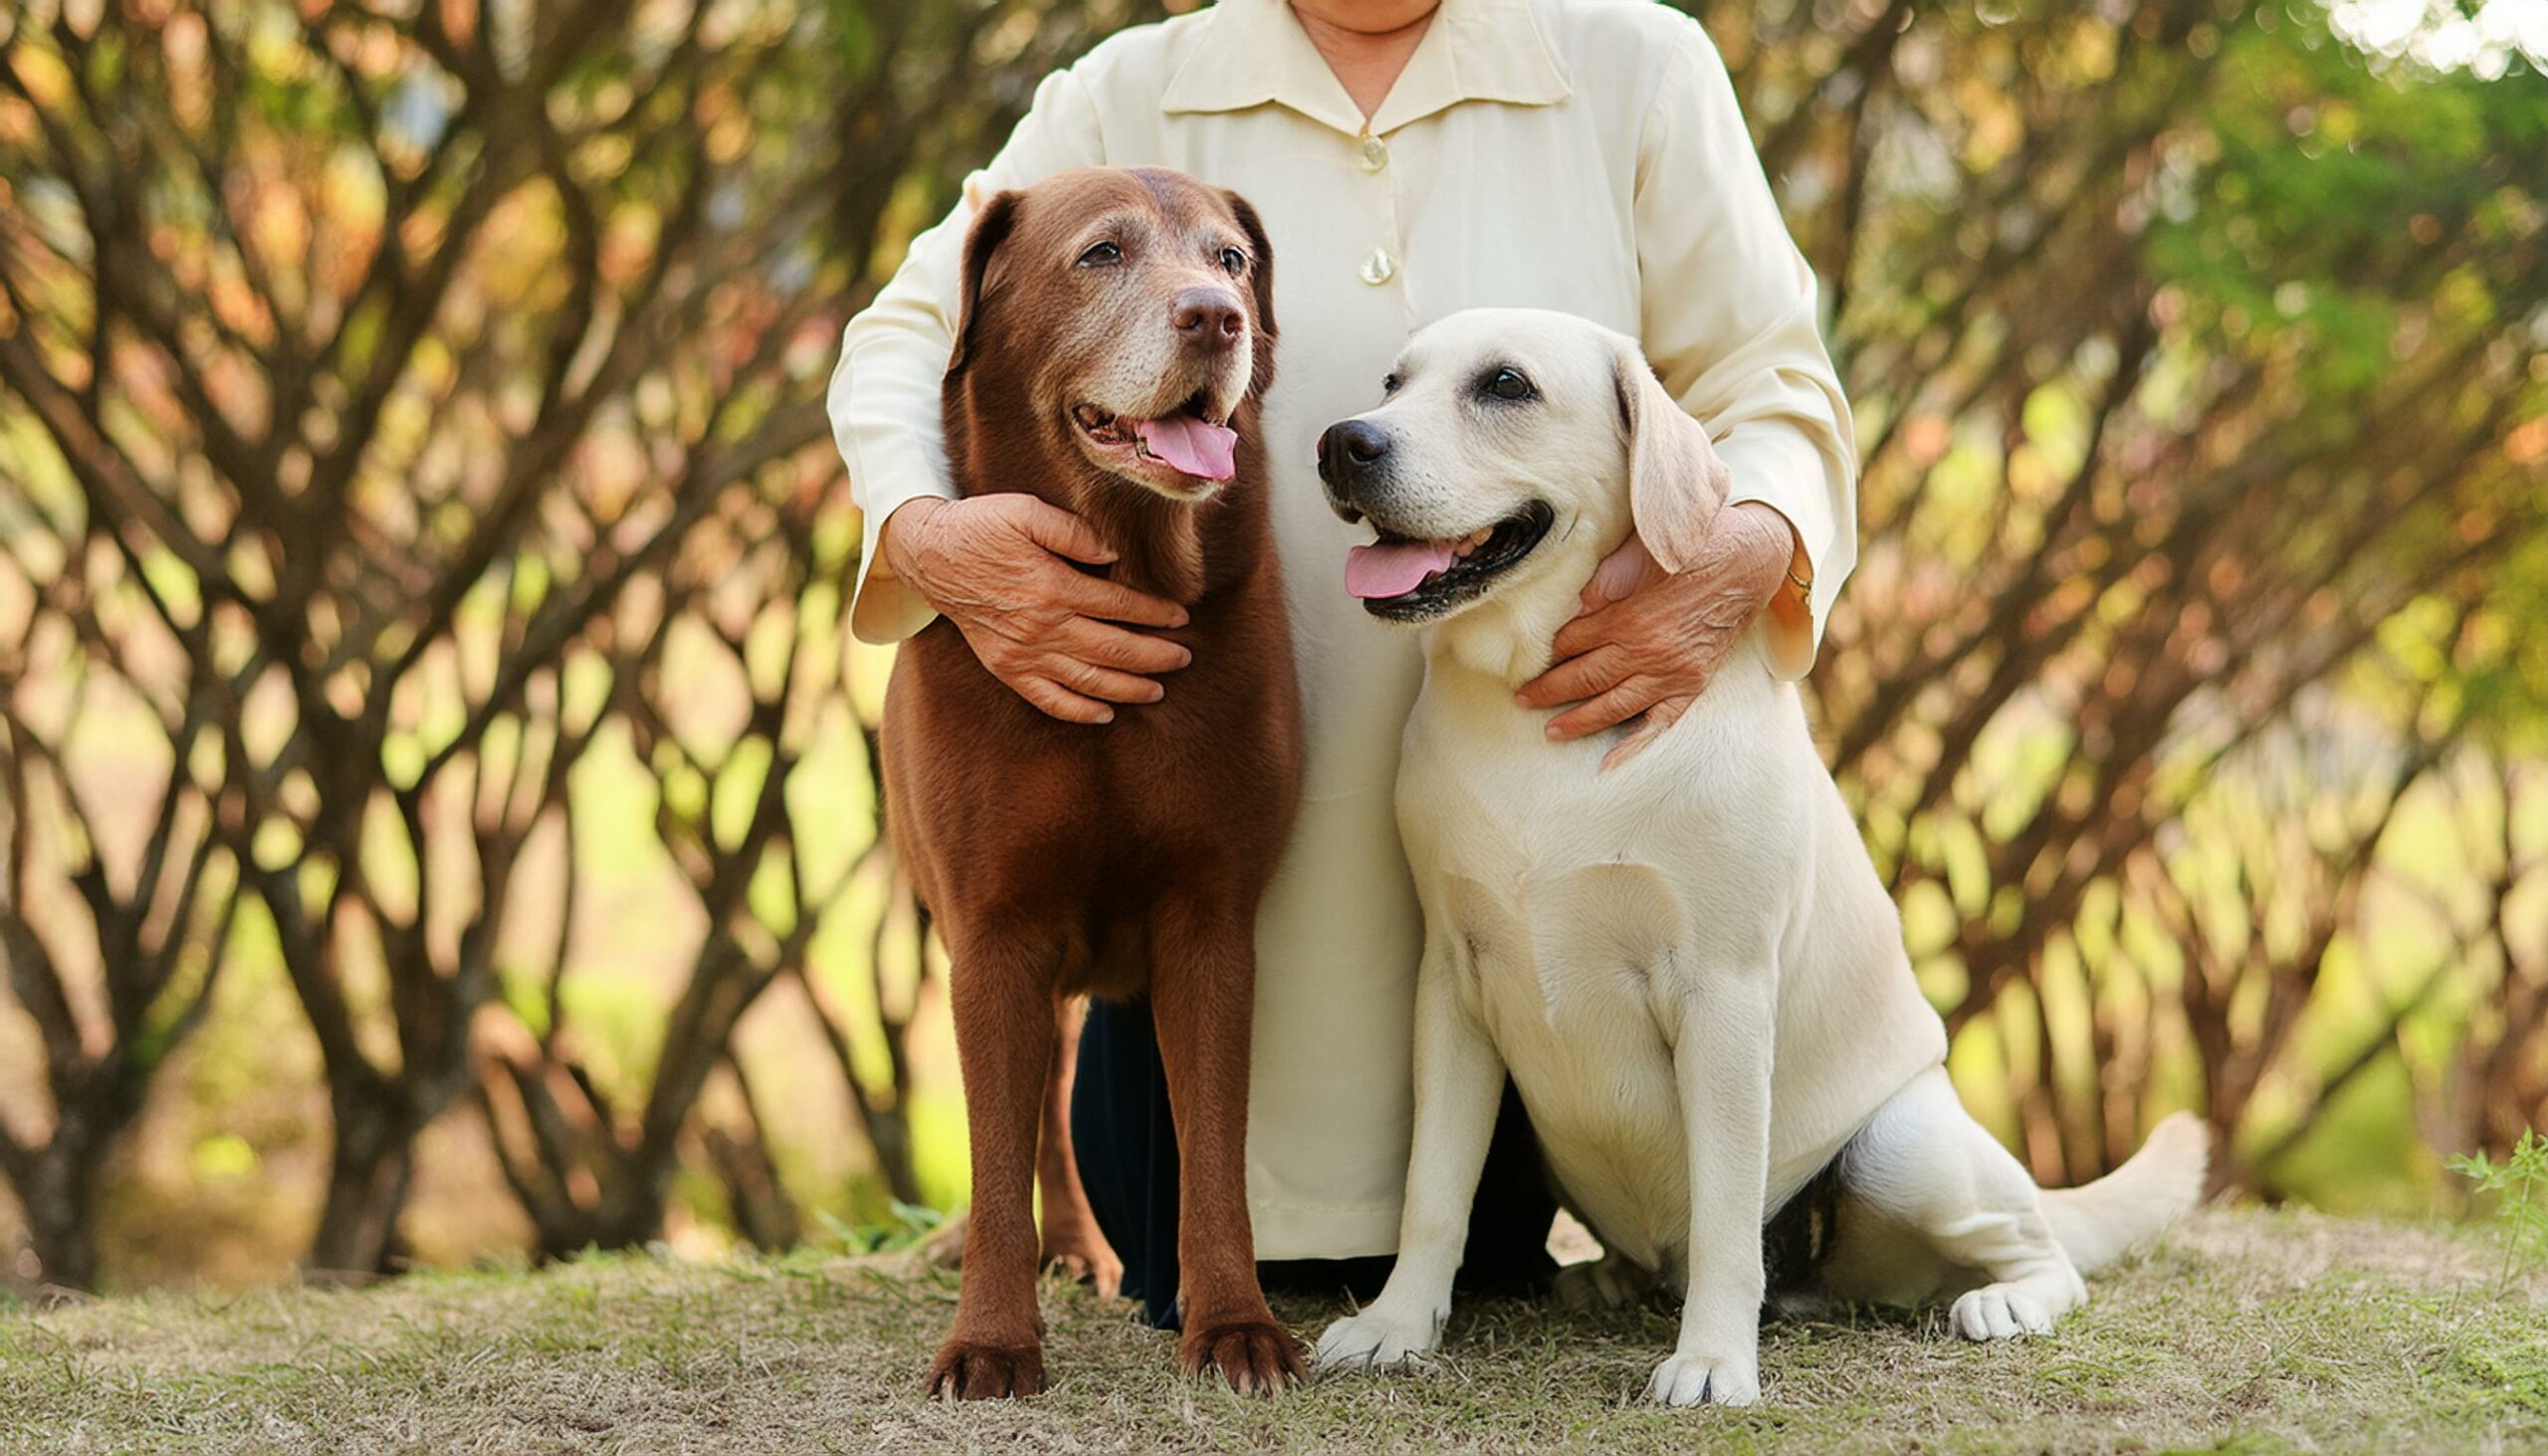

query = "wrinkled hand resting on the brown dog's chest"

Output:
[[877, 495, 1195, 725]]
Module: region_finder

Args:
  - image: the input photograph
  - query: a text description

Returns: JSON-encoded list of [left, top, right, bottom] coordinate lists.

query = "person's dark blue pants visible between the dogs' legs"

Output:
[[1070, 1002, 1557, 1329]]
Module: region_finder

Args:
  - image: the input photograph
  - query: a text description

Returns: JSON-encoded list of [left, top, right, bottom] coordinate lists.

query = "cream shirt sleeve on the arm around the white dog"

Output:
[[1636, 23, 1857, 679]]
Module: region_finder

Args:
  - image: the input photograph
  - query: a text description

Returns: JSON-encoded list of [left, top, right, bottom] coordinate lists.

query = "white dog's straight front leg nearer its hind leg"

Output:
[[1646, 964, 1779, 1405]]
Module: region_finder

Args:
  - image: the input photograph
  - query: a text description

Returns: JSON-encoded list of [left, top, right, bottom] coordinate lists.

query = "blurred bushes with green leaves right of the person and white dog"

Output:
[[1707, 0, 2548, 1206]]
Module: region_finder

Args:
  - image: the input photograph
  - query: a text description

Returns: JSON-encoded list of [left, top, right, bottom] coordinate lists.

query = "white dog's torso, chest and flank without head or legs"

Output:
[[1398, 663, 1944, 1275]]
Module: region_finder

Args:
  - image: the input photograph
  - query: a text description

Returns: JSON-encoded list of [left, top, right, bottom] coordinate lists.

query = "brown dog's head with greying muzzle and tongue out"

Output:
[[948, 168, 1274, 500]]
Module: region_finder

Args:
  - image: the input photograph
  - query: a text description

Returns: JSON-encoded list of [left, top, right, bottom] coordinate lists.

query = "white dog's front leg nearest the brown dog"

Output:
[[1315, 951, 1503, 1369]]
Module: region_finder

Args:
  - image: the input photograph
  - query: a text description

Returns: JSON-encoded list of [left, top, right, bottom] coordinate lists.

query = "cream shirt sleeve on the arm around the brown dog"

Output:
[[828, 72, 1106, 643]]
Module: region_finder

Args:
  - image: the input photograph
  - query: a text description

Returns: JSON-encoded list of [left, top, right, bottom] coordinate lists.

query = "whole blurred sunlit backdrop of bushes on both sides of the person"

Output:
[[0, 0, 2548, 1288]]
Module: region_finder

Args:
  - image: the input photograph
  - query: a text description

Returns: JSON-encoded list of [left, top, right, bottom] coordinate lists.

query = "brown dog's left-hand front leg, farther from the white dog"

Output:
[[928, 934, 1060, 1400]]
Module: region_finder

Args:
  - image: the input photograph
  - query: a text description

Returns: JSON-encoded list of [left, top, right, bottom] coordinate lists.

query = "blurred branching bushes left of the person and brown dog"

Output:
[[0, 0, 1157, 1285]]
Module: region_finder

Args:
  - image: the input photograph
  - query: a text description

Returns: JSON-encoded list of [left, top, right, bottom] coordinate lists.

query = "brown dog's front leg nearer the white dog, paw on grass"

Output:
[[1150, 895, 1302, 1395]]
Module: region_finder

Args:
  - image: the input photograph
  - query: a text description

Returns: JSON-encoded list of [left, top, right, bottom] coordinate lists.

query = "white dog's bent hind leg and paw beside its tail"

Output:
[[1839, 1066, 2087, 1339]]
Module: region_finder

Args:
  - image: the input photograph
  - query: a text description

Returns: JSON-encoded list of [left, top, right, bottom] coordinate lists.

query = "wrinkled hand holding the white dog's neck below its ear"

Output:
[[1516, 500, 1797, 770]]
